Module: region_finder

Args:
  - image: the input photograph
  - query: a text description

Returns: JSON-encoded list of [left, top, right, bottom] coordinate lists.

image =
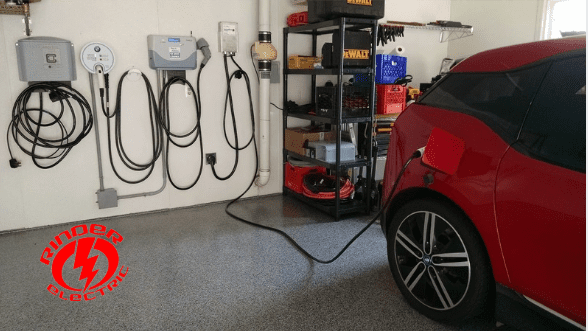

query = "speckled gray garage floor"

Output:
[[0, 196, 492, 330]]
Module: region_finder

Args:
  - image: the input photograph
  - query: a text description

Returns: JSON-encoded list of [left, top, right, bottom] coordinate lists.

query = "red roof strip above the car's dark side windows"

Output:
[[451, 37, 586, 73]]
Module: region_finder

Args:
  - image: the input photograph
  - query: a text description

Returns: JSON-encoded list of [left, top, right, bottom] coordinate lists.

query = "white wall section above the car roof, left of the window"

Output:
[[448, 0, 543, 58]]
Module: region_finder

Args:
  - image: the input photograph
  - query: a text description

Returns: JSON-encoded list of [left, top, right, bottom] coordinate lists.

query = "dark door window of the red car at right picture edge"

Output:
[[519, 52, 586, 172]]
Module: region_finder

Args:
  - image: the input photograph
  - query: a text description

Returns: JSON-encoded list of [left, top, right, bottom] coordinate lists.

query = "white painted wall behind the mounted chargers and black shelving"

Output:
[[0, 0, 450, 231]]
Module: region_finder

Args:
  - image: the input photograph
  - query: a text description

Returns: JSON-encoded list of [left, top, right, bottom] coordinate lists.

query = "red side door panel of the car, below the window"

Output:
[[496, 148, 586, 324]]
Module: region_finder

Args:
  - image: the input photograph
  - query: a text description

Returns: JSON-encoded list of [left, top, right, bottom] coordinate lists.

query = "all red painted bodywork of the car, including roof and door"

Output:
[[382, 36, 586, 325]]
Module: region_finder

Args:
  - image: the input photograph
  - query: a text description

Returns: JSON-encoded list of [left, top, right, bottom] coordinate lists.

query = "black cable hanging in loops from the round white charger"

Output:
[[100, 71, 163, 184]]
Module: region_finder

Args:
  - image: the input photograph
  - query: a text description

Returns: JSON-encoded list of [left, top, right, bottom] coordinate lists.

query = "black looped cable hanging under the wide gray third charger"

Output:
[[157, 65, 204, 190]]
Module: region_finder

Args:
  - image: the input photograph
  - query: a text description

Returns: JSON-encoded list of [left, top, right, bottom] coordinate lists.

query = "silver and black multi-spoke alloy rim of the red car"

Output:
[[394, 211, 471, 310]]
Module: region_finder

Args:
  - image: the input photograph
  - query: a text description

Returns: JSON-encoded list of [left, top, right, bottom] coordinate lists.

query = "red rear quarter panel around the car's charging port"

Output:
[[384, 104, 509, 284]]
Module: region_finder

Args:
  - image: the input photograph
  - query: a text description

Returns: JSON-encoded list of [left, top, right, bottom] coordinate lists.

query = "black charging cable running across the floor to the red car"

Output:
[[225, 147, 425, 264]]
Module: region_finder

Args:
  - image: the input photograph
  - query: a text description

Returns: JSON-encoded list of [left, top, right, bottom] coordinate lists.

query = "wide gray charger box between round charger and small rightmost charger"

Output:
[[147, 35, 197, 70]]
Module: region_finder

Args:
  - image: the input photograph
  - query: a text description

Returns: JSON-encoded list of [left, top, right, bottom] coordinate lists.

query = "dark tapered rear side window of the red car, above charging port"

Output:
[[421, 64, 548, 144]]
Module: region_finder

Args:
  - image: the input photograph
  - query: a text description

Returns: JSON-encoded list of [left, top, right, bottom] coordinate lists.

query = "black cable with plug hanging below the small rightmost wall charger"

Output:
[[208, 54, 257, 182]]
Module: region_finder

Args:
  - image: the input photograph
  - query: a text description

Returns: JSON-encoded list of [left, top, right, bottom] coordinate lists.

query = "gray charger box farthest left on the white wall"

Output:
[[16, 37, 76, 82]]
